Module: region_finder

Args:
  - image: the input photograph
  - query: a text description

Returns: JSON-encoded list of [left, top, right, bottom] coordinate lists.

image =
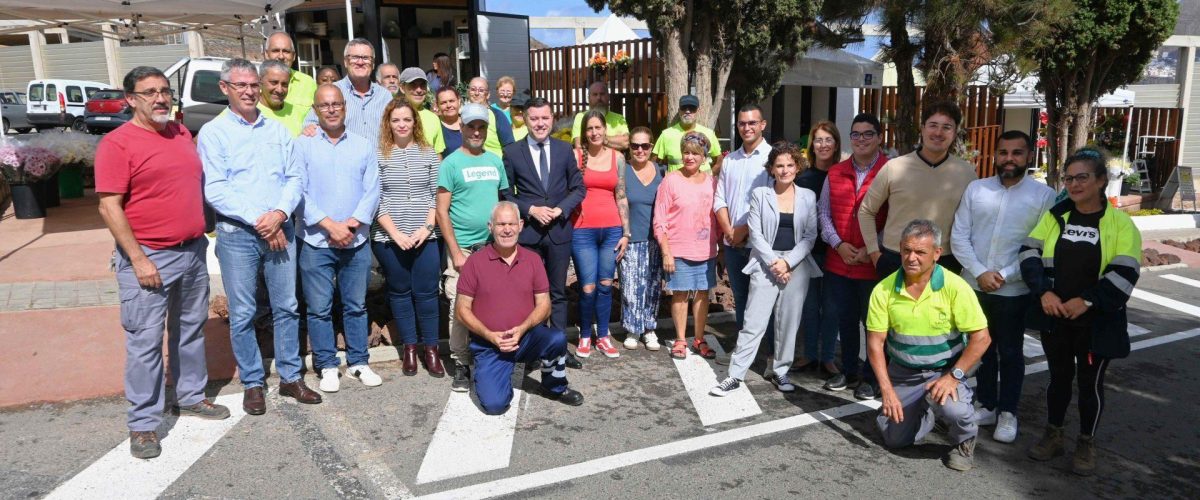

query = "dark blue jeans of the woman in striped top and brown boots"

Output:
[[371, 240, 442, 345]]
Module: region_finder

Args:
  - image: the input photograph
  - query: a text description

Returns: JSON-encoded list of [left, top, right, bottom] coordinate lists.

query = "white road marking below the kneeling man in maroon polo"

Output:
[[416, 390, 523, 484]]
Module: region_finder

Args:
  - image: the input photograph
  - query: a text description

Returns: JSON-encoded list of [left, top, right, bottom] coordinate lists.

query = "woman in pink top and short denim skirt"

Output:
[[654, 132, 718, 360]]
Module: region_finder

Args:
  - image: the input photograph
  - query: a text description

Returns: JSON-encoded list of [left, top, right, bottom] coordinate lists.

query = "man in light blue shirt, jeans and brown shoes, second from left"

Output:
[[197, 59, 320, 415]]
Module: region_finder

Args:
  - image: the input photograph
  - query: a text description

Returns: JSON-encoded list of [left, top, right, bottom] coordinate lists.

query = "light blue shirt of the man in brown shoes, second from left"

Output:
[[196, 109, 304, 225]]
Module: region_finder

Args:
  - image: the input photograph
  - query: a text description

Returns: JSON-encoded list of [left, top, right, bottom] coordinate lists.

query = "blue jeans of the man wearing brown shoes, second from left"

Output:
[[216, 217, 301, 388]]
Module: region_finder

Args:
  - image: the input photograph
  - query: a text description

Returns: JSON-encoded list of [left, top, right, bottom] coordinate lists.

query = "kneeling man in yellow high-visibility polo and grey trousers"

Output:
[[866, 219, 991, 470]]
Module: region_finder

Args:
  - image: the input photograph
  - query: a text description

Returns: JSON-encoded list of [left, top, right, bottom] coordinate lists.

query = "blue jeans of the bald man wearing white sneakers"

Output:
[[300, 243, 371, 371]]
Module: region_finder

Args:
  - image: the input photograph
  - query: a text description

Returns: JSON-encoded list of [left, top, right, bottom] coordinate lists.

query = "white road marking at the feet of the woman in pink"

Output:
[[672, 336, 762, 427]]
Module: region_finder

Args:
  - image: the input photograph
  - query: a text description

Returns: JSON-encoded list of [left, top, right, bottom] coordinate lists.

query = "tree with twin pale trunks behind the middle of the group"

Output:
[[587, 0, 846, 127]]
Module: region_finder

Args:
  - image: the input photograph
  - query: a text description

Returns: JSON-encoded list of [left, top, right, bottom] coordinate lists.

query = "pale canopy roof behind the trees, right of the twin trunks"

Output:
[[780, 47, 883, 89]]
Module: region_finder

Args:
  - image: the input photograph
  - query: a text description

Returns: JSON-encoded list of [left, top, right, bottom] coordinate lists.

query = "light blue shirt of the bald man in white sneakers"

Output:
[[292, 129, 379, 248]]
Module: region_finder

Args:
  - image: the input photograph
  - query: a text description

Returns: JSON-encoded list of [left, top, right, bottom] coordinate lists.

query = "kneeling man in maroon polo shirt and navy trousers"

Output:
[[455, 201, 583, 415]]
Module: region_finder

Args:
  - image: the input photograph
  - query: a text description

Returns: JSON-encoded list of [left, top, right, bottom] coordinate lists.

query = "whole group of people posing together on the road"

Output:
[[96, 34, 1140, 474]]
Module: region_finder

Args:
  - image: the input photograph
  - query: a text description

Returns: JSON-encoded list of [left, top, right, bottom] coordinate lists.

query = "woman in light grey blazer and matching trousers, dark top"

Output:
[[709, 143, 821, 396]]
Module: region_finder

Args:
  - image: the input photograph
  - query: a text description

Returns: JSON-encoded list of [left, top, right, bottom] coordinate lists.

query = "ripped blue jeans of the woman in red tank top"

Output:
[[571, 225, 620, 338]]
